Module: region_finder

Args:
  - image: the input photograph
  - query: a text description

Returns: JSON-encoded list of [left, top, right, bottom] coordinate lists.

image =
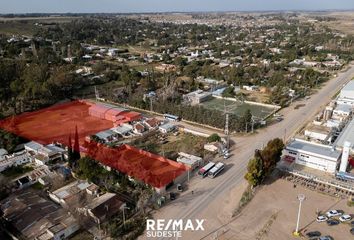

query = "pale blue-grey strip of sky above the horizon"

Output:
[[0, 0, 354, 13]]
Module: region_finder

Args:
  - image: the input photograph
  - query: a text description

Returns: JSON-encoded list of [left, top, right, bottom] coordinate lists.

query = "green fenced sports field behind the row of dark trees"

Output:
[[201, 98, 274, 119]]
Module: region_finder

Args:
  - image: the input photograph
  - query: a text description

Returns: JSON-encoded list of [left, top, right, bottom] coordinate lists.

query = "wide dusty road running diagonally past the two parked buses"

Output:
[[149, 65, 354, 239]]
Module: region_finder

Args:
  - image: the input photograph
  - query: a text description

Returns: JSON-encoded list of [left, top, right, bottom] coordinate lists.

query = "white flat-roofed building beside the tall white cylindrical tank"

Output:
[[283, 139, 341, 174]]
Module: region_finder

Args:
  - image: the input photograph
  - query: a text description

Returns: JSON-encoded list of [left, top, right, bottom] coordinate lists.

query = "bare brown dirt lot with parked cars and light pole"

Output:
[[219, 180, 354, 240]]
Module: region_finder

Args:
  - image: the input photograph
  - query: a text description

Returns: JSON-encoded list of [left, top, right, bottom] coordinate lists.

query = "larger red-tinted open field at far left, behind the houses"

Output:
[[0, 101, 113, 144]]
